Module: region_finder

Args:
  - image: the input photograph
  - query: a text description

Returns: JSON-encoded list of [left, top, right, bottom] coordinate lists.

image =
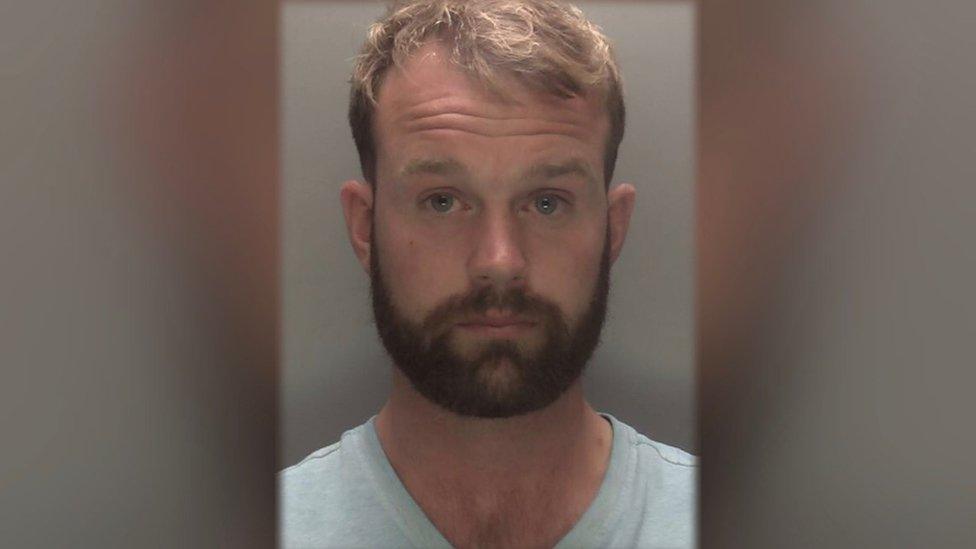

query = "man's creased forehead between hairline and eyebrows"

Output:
[[374, 42, 609, 184]]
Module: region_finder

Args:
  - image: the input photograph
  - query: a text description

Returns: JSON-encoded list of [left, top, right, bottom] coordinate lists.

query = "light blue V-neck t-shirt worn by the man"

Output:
[[278, 414, 698, 548]]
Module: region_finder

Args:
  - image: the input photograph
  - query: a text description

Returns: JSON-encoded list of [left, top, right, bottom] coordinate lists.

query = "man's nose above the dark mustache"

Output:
[[468, 212, 527, 292]]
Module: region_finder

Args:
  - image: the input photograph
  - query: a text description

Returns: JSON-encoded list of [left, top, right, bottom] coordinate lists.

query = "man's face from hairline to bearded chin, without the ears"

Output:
[[369, 44, 611, 417]]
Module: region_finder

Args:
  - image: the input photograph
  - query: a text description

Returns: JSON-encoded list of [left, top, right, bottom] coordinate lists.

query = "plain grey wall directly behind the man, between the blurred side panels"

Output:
[[280, 1, 697, 465]]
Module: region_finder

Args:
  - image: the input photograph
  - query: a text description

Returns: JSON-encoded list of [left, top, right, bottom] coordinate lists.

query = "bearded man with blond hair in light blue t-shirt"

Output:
[[281, 0, 695, 547]]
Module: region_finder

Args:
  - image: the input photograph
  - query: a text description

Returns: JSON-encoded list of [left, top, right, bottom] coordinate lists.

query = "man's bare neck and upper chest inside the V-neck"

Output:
[[376, 371, 612, 547]]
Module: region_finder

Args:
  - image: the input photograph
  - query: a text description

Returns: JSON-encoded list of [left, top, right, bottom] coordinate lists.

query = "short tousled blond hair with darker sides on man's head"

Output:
[[349, 0, 624, 185]]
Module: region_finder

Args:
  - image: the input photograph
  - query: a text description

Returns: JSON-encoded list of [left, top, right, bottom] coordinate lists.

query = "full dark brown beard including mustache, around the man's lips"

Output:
[[370, 224, 610, 418]]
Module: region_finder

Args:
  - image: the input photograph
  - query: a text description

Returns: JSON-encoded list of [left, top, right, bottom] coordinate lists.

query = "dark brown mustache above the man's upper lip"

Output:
[[422, 286, 565, 333]]
